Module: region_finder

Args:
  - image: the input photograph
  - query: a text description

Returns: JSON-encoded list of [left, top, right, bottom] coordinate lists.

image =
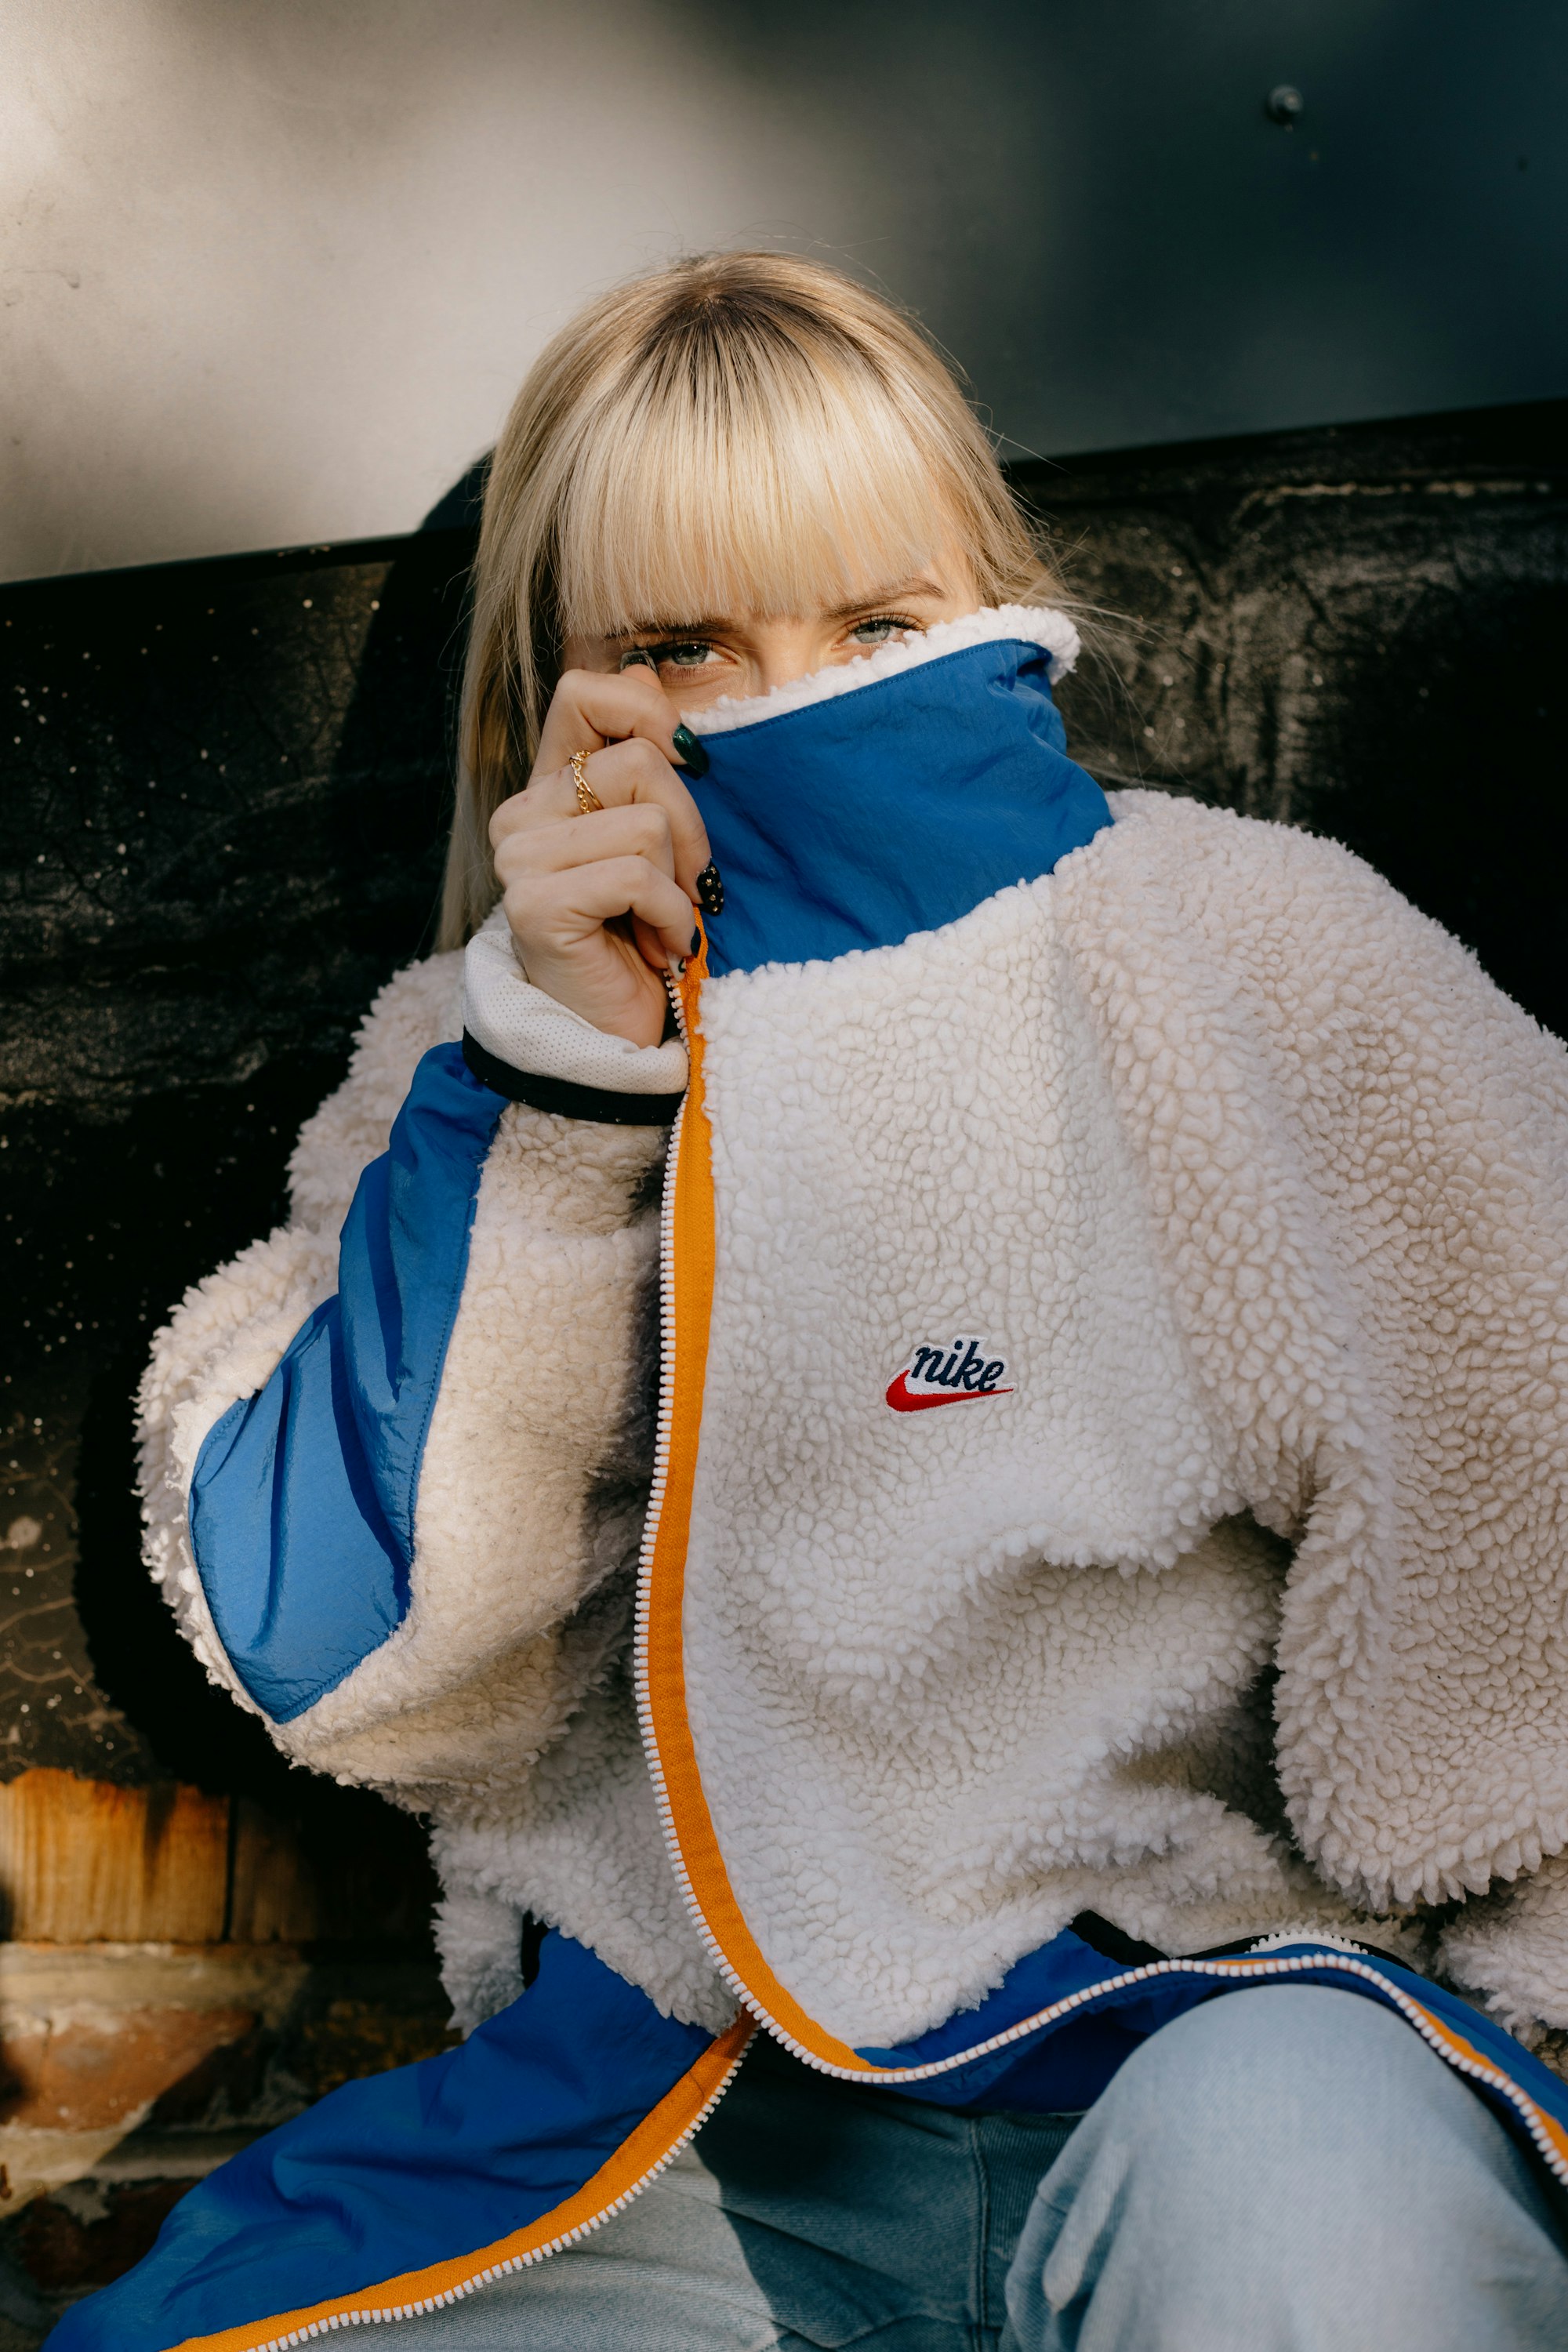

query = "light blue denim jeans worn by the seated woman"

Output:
[[397, 1985, 1568, 2352]]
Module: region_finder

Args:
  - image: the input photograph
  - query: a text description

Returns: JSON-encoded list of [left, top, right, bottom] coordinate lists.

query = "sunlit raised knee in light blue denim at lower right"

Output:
[[1008, 1985, 1568, 2352]]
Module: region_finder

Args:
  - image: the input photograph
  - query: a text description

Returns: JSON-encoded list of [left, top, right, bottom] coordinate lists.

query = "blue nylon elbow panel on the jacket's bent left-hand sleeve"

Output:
[[191, 1044, 506, 1724]]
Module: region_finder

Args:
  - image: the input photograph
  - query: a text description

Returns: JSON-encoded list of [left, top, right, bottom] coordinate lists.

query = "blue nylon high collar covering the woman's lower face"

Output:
[[687, 640, 1112, 974]]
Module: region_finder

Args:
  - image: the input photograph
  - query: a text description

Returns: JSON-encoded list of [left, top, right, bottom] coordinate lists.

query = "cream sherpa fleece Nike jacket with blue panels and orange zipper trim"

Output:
[[61, 609, 1568, 2347]]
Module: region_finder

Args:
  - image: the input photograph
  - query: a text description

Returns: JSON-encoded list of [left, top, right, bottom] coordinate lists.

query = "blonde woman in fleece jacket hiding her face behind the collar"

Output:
[[56, 254, 1568, 2352]]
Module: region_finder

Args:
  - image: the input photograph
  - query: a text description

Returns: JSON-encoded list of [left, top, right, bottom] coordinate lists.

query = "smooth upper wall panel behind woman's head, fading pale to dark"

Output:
[[0, 0, 1568, 579]]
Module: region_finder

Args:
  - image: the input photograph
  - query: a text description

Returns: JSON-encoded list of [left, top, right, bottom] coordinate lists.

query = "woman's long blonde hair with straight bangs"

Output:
[[440, 254, 1058, 948]]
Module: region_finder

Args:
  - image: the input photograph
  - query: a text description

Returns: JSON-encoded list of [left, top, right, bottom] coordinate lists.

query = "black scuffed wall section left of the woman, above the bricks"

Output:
[[0, 532, 473, 1813]]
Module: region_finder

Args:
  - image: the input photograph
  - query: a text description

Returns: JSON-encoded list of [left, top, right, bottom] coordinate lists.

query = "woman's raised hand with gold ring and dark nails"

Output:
[[489, 668, 708, 1044]]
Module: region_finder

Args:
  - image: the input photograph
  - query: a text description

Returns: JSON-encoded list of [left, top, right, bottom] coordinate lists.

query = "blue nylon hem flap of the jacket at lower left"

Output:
[[49, 1936, 713, 2352]]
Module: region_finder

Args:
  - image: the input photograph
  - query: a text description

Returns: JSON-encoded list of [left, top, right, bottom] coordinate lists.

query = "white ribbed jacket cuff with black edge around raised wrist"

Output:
[[463, 908, 687, 1127]]
